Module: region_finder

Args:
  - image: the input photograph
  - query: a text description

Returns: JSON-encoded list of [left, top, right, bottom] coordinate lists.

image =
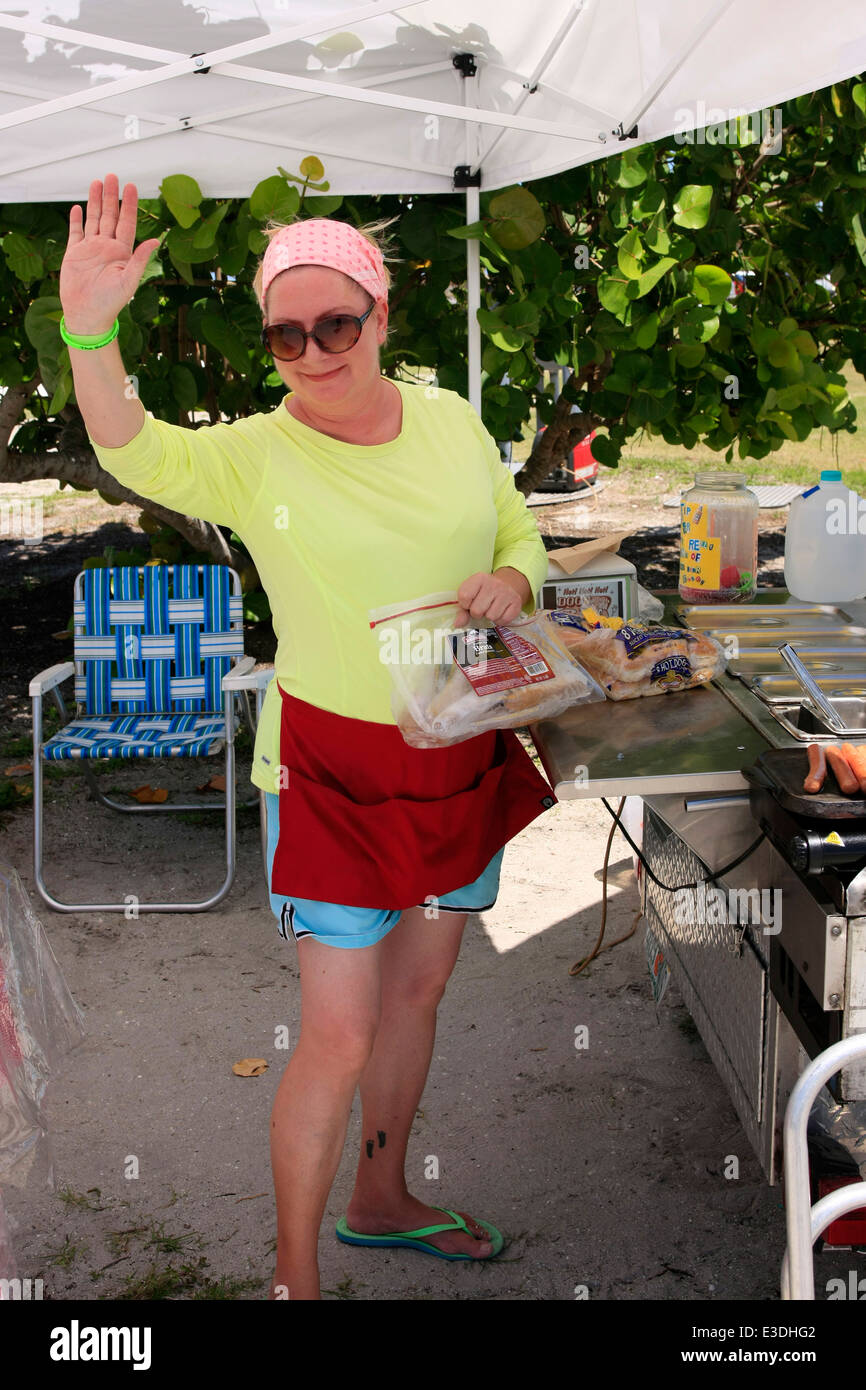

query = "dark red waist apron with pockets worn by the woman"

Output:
[[271, 687, 557, 909]]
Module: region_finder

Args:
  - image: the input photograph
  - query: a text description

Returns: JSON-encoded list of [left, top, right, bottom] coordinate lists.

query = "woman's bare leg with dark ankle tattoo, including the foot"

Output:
[[346, 908, 491, 1258]]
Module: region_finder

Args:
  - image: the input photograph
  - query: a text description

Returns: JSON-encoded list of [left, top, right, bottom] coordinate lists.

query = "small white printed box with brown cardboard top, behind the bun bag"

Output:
[[539, 531, 638, 620]]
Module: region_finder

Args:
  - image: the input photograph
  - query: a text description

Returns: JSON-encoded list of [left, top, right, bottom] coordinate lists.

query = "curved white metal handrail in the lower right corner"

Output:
[[781, 1033, 866, 1301]]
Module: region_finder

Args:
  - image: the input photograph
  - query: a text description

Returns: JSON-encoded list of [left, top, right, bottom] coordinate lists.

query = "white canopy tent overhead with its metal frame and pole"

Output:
[[0, 0, 866, 409]]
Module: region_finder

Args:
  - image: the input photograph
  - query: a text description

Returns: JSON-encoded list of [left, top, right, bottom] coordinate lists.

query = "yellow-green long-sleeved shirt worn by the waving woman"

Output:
[[90, 381, 548, 791]]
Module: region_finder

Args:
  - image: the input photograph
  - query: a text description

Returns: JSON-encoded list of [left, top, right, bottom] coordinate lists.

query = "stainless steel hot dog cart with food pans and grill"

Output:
[[531, 589, 866, 1183]]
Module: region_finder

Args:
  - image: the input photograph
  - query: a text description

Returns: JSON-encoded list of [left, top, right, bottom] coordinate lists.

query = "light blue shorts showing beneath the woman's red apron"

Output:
[[264, 792, 505, 948]]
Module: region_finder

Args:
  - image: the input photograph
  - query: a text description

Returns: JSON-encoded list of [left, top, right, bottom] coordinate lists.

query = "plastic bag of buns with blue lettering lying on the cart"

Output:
[[546, 607, 726, 699]]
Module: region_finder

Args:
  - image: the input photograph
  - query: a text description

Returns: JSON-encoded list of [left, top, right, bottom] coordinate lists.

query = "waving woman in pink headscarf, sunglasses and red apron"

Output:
[[60, 174, 556, 1300]]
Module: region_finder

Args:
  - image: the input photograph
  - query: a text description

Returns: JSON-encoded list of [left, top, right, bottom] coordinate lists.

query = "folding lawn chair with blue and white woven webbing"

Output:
[[29, 564, 274, 916]]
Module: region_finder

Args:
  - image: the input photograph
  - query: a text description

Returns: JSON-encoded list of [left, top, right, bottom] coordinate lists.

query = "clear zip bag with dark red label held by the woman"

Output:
[[370, 589, 605, 748]]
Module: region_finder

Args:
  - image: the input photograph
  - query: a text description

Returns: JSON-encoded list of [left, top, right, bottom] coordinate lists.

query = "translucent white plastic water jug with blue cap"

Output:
[[785, 468, 866, 603]]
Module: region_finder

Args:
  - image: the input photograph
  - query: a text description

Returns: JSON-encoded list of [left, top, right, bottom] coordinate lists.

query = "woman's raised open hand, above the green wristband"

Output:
[[60, 174, 160, 335]]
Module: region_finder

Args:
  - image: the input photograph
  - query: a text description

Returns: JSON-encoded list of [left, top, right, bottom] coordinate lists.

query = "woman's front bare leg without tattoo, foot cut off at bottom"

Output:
[[271, 937, 386, 1298]]
